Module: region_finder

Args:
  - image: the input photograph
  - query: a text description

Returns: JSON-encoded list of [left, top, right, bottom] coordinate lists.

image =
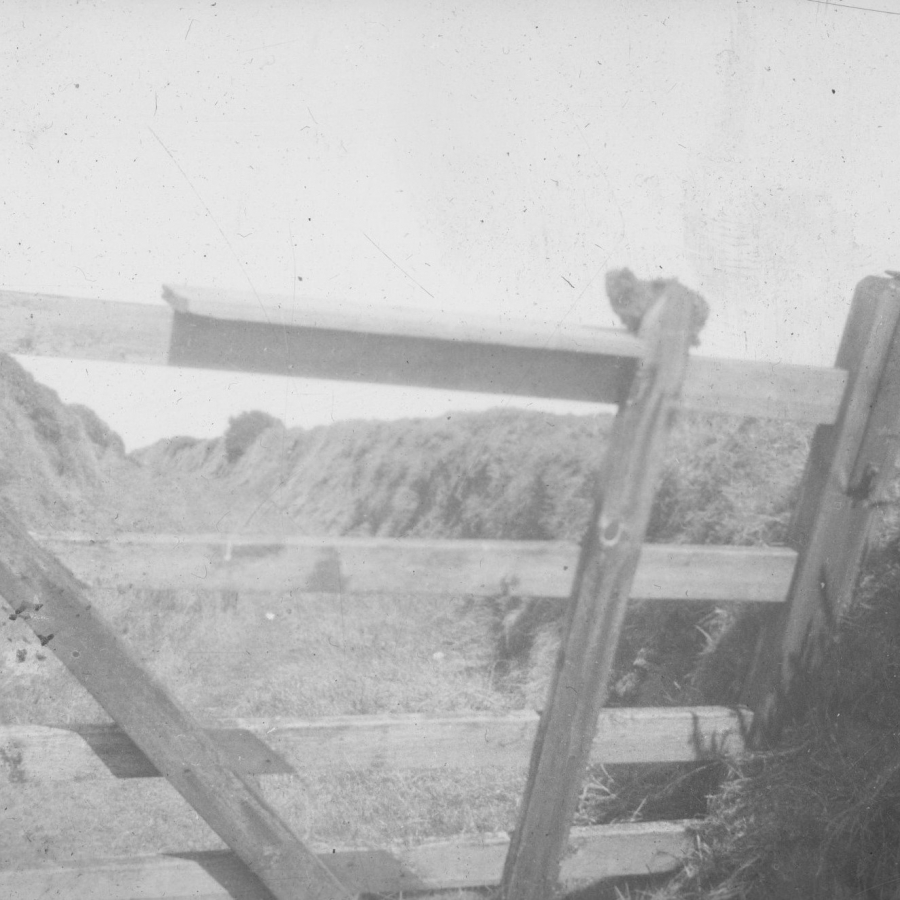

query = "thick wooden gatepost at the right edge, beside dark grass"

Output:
[[744, 278, 900, 744]]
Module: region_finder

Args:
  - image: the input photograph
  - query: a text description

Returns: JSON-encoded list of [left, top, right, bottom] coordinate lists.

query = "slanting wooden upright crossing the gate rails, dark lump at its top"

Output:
[[501, 283, 693, 900]]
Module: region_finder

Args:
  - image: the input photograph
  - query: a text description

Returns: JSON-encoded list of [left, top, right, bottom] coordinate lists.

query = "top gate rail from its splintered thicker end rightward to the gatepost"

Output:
[[163, 286, 846, 422]]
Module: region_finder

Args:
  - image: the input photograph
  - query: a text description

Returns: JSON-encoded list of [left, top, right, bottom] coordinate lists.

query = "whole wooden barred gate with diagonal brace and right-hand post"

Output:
[[0, 278, 900, 900]]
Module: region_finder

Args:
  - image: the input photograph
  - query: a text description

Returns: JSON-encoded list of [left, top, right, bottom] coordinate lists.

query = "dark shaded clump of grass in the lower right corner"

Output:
[[640, 540, 900, 900]]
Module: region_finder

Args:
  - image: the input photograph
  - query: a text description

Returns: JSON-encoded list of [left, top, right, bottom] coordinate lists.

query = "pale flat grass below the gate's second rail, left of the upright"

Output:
[[0, 591, 523, 866]]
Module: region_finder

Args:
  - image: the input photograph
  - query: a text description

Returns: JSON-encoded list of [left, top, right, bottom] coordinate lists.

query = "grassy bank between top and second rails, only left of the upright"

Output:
[[135, 412, 611, 539]]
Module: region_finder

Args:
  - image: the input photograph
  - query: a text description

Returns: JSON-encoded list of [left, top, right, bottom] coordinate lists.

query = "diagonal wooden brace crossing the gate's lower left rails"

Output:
[[0, 509, 351, 900]]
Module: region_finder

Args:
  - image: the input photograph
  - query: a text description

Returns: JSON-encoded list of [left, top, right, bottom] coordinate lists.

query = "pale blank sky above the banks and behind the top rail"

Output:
[[0, 0, 900, 447]]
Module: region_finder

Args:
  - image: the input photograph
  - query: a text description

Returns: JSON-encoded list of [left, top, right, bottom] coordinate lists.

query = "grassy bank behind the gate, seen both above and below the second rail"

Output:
[[135, 411, 809, 706]]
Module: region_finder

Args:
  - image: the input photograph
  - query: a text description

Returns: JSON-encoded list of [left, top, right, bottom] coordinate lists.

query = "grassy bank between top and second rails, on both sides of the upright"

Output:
[[134, 411, 809, 544]]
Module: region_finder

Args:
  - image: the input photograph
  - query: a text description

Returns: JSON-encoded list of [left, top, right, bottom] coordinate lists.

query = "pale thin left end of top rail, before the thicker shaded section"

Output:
[[0, 291, 172, 366]]
